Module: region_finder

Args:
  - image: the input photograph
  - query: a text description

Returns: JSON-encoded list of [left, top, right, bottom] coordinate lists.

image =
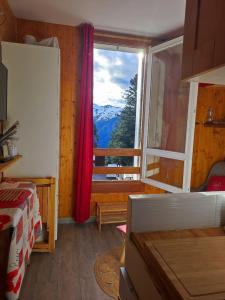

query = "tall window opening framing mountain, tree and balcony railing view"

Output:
[[93, 44, 144, 180]]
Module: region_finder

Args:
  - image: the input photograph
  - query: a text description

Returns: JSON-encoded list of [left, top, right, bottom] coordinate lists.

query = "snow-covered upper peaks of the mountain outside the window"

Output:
[[94, 104, 122, 121]]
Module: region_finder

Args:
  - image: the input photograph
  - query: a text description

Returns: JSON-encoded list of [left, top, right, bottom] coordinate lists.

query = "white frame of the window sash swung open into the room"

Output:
[[141, 37, 198, 193]]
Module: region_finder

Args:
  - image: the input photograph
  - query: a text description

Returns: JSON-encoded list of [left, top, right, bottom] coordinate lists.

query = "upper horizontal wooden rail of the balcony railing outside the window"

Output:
[[94, 148, 141, 156]]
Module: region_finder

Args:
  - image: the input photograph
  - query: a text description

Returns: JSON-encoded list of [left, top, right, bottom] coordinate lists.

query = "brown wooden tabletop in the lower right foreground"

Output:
[[132, 228, 225, 300]]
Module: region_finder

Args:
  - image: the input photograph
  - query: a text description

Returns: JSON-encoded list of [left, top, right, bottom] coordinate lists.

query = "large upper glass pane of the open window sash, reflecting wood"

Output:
[[147, 45, 189, 153]]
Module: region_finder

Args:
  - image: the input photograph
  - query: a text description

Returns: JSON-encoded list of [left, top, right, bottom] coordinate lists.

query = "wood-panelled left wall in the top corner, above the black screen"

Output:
[[0, 0, 17, 42]]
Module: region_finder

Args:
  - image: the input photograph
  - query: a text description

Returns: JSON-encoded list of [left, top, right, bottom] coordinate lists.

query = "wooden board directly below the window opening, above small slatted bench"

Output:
[[92, 180, 145, 193]]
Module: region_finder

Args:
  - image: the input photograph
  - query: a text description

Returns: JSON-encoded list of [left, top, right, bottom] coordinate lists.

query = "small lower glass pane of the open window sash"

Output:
[[145, 155, 184, 188]]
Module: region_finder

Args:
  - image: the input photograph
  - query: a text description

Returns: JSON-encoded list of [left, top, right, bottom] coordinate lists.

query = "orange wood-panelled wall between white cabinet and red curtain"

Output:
[[18, 19, 81, 217]]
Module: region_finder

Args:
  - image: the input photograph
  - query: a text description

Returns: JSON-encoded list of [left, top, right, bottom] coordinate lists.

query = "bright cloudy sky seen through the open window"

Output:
[[94, 49, 138, 107]]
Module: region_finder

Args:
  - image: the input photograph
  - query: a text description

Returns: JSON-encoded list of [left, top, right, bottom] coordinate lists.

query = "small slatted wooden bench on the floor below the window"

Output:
[[97, 202, 127, 230]]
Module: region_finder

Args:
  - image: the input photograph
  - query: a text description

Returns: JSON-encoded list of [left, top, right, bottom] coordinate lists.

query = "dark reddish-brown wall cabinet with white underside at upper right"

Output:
[[182, 0, 225, 83]]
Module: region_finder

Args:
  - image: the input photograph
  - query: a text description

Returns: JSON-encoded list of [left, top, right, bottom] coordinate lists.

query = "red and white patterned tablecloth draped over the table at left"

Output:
[[0, 182, 41, 300]]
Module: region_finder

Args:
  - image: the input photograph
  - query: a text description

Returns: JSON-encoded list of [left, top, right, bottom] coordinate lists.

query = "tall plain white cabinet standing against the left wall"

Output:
[[1, 42, 60, 238]]
